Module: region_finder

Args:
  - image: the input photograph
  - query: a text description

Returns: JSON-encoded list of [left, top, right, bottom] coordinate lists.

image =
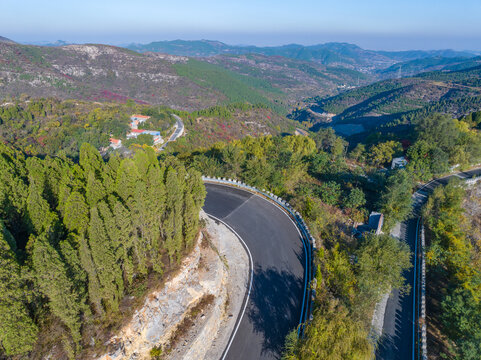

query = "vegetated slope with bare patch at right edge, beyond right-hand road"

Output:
[[424, 182, 481, 360]]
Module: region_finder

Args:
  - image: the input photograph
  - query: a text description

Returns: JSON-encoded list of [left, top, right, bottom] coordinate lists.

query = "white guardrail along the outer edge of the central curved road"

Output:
[[202, 176, 316, 336]]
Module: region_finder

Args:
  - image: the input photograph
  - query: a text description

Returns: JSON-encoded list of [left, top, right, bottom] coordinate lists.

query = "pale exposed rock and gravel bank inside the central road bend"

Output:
[[99, 214, 248, 360]]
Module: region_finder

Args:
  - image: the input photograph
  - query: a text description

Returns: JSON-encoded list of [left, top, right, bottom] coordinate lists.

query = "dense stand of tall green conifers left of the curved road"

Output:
[[0, 144, 205, 358]]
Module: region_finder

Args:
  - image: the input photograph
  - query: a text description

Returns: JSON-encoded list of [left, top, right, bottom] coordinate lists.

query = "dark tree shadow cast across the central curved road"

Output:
[[248, 266, 303, 358]]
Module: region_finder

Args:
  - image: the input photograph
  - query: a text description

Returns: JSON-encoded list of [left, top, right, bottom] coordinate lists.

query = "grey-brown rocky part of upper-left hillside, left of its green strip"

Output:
[[0, 43, 218, 109]]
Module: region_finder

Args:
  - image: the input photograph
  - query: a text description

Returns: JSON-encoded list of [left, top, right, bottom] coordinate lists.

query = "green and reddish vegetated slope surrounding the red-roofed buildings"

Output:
[[0, 98, 295, 158]]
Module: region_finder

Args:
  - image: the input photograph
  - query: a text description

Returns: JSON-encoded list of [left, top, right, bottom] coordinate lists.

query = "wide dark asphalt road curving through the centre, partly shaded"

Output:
[[204, 183, 305, 360]]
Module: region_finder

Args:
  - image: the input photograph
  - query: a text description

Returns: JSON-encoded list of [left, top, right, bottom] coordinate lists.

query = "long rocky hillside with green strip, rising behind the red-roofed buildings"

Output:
[[0, 42, 370, 113]]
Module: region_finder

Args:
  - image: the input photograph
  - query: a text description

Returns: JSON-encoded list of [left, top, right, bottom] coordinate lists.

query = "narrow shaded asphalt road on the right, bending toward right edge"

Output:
[[376, 169, 481, 360]]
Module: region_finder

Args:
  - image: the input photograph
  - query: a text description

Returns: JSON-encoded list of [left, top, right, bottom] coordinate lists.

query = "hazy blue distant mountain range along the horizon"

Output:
[[127, 40, 475, 72]]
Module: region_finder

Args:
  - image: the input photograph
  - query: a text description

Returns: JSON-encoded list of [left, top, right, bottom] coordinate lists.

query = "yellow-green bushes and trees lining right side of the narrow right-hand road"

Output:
[[423, 181, 481, 360]]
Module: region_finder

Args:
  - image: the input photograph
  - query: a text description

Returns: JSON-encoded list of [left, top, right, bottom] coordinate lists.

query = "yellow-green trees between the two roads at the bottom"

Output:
[[283, 234, 411, 360]]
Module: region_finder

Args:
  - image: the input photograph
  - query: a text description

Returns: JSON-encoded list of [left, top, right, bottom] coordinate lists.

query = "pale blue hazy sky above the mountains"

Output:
[[0, 0, 481, 50]]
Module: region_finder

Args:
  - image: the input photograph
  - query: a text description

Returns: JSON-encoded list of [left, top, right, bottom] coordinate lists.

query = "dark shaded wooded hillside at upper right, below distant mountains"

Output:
[[292, 66, 481, 138]]
